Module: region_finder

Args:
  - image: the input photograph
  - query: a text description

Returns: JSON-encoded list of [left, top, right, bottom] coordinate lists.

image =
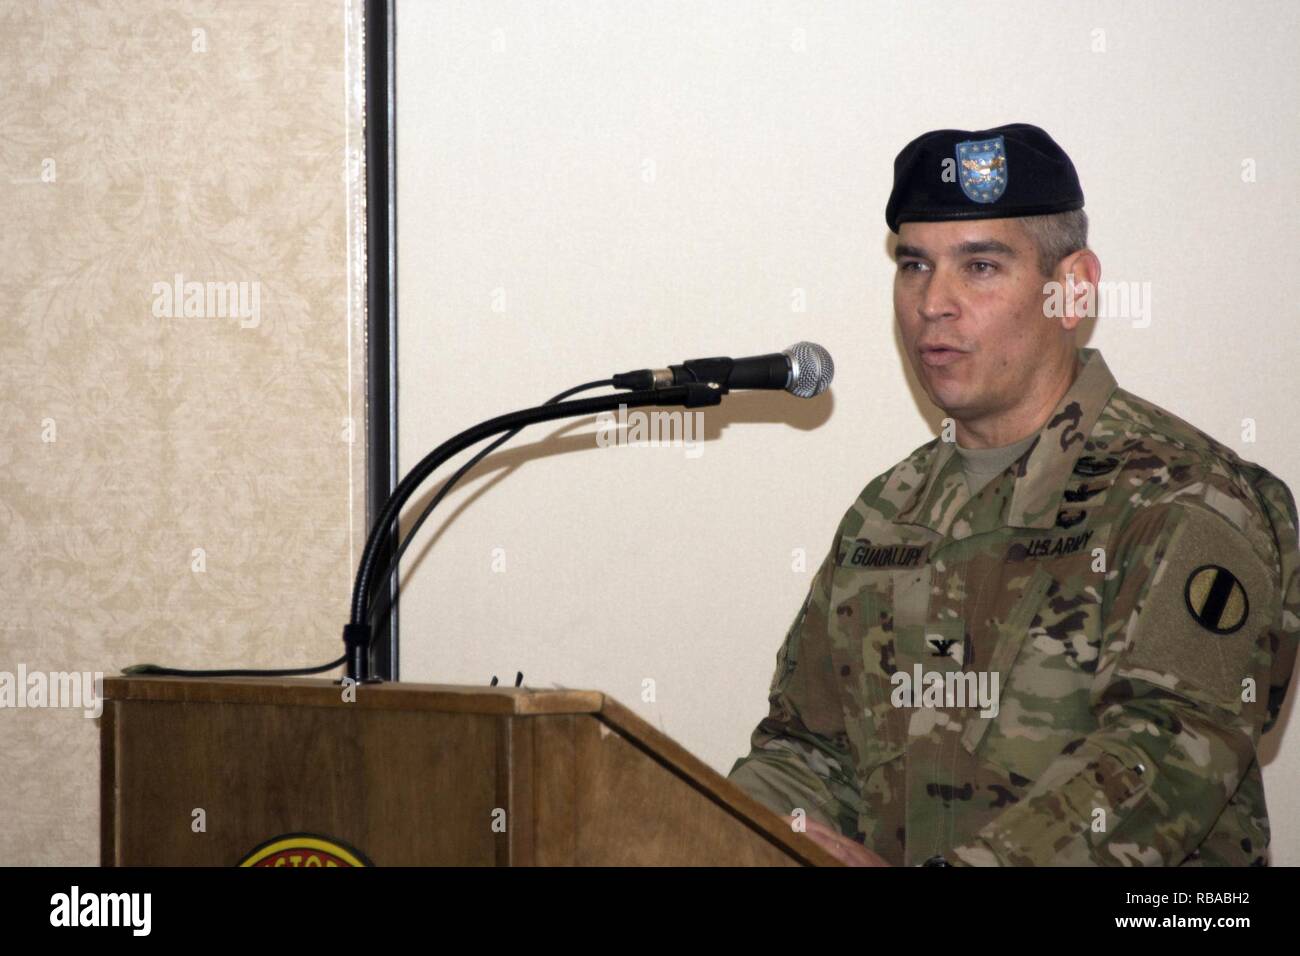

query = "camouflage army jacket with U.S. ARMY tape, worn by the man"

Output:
[[729, 349, 1300, 865]]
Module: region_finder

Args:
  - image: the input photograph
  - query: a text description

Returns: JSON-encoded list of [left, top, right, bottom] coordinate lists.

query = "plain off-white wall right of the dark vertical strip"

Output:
[[398, 0, 1300, 864]]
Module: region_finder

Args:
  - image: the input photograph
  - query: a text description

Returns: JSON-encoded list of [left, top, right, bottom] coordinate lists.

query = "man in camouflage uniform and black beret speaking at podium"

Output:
[[729, 125, 1300, 866]]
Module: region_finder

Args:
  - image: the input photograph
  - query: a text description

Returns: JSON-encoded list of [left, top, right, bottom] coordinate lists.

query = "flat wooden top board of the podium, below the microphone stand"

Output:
[[104, 676, 606, 717]]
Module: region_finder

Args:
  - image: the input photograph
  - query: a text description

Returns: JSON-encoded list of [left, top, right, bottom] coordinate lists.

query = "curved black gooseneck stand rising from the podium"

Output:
[[343, 378, 728, 682]]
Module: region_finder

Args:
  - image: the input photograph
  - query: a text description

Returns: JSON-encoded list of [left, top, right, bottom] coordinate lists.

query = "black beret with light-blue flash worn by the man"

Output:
[[885, 122, 1083, 233]]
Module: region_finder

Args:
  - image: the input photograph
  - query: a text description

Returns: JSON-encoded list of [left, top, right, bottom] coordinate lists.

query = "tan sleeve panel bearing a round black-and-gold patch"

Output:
[[1117, 506, 1279, 714]]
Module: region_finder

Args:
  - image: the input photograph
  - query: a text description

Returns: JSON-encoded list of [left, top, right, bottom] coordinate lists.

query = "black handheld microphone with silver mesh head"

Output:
[[612, 342, 835, 398]]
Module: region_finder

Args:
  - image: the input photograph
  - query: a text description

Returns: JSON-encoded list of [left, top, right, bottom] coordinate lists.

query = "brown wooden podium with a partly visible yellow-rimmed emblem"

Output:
[[100, 678, 840, 866]]
